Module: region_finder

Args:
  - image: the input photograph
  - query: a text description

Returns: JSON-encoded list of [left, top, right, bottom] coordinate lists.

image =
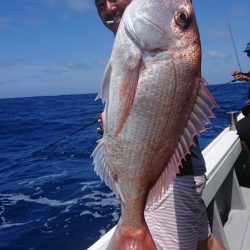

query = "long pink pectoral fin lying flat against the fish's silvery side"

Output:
[[115, 59, 144, 136]]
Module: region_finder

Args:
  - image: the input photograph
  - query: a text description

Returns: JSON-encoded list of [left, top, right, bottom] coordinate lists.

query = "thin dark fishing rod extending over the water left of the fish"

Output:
[[0, 118, 99, 172]]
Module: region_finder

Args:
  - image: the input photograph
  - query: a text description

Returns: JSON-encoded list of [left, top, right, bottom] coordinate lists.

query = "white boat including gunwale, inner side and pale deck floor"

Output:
[[88, 116, 250, 250]]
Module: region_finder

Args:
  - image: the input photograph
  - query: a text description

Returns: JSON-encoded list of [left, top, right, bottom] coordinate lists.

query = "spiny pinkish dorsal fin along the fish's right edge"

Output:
[[147, 79, 218, 207]]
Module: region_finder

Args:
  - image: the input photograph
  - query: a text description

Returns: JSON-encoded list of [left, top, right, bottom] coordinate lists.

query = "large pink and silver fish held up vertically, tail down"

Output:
[[93, 0, 216, 250]]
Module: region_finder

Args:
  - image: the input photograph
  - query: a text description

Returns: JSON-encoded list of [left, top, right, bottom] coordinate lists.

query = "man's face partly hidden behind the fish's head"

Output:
[[95, 0, 132, 34]]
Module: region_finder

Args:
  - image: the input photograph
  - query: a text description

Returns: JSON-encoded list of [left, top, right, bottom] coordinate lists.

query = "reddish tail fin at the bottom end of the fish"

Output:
[[106, 222, 156, 250]]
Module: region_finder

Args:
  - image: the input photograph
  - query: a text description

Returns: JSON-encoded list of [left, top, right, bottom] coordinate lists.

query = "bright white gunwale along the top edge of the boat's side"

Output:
[[88, 114, 248, 250]]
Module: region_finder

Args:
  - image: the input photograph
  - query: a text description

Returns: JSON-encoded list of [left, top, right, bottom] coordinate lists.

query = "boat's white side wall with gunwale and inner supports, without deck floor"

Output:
[[88, 114, 246, 250]]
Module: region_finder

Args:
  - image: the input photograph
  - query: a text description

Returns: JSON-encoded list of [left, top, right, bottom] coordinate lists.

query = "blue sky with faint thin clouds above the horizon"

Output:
[[0, 0, 250, 98]]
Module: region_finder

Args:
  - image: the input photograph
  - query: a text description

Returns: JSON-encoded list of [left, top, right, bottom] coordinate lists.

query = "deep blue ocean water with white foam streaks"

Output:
[[0, 84, 247, 250]]
